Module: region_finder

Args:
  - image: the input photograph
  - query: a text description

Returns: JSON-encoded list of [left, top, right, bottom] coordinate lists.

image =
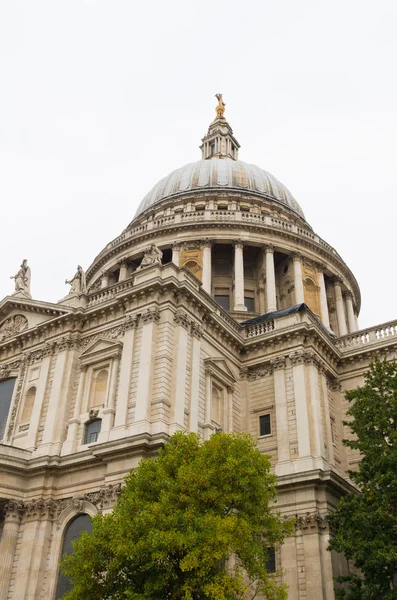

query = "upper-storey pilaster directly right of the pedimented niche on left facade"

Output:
[[109, 315, 138, 440]]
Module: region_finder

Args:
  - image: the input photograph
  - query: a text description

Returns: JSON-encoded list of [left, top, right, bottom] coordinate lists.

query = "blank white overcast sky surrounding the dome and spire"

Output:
[[0, 0, 397, 327]]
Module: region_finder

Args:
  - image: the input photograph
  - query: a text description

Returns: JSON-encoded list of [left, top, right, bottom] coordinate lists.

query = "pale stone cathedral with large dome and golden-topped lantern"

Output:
[[0, 94, 397, 600]]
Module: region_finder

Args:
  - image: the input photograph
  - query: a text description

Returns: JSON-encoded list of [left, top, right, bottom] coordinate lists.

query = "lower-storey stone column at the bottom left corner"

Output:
[[0, 500, 25, 600]]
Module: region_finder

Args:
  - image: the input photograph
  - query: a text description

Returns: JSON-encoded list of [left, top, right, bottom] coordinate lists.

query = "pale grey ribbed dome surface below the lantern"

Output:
[[135, 158, 305, 218]]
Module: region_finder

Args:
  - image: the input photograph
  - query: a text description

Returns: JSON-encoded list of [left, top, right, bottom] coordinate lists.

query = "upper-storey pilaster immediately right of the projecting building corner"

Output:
[[169, 308, 190, 435]]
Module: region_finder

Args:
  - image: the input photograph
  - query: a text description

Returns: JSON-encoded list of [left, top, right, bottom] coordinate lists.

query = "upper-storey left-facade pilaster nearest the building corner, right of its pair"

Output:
[[133, 307, 160, 433]]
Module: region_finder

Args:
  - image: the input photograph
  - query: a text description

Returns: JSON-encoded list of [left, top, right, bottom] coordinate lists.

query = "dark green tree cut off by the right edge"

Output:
[[330, 360, 397, 600]]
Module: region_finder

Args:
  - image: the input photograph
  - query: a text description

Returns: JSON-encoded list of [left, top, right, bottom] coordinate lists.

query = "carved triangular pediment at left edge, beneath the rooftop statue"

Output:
[[0, 296, 69, 343]]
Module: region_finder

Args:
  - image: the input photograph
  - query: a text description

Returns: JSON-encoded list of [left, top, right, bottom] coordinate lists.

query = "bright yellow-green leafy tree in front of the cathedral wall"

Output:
[[62, 432, 292, 600]]
